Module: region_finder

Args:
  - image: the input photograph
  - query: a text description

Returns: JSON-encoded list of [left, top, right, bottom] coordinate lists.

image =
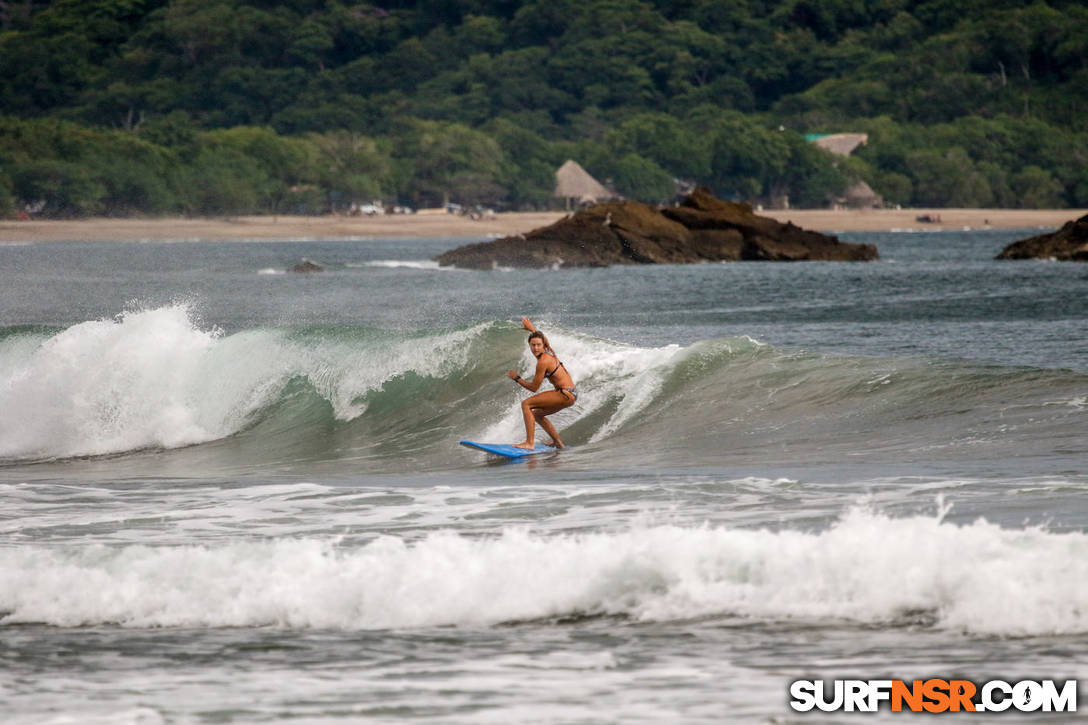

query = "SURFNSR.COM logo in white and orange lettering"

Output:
[[790, 678, 1077, 713]]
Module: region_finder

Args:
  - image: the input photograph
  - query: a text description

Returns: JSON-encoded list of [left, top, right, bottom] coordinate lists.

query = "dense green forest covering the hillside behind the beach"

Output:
[[0, 0, 1088, 216]]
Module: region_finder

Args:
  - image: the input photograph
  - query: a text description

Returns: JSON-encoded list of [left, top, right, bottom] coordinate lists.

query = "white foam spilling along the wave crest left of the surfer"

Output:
[[0, 304, 487, 458]]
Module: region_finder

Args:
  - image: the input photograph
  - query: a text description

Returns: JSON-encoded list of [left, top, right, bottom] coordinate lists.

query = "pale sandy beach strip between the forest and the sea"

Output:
[[0, 209, 1088, 244]]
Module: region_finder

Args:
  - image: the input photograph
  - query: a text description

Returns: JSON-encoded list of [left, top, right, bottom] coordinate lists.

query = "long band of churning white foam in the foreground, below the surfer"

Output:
[[0, 509, 1088, 636]]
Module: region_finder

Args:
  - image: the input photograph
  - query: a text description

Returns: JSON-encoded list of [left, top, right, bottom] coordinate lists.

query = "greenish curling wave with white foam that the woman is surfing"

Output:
[[0, 305, 1088, 468]]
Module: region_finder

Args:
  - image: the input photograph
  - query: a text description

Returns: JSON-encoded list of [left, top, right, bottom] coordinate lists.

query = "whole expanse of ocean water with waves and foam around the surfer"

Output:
[[0, 230, 1088, 724]]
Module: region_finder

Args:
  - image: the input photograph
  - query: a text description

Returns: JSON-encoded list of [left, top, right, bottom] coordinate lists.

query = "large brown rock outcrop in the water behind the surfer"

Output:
[[437, 188, 877, 269]]
